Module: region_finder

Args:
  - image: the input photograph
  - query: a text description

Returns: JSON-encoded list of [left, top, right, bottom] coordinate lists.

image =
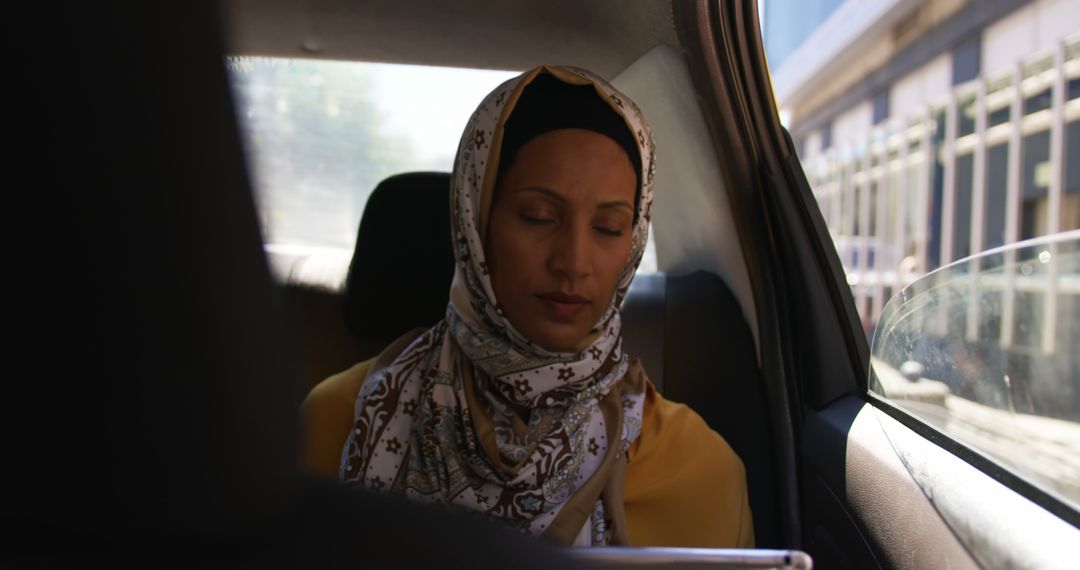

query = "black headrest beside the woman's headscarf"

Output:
[[345, 173, 454, 343]]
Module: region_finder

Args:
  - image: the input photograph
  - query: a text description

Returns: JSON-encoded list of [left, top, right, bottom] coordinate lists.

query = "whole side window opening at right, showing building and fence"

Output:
[[758, 0, 1080, 511]]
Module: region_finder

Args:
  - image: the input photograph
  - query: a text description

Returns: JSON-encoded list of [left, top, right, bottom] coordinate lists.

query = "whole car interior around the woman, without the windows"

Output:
[[8, 0, 1080, 568]]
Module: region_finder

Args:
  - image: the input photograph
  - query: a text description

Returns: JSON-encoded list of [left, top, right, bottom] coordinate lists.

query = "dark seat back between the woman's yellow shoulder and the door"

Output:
[[622, 271, 780, 546]]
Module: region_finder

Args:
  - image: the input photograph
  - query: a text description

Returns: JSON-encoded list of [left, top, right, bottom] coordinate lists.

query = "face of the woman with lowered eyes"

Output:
[[486, 128, 637, 352]]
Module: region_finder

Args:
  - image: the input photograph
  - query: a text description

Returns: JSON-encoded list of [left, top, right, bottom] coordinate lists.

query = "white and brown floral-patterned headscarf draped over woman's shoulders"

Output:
[[339, 66, 653, 545]]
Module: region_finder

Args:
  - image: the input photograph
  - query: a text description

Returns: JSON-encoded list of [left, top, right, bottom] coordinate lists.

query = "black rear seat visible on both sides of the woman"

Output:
[[280, 167, 777, 544]]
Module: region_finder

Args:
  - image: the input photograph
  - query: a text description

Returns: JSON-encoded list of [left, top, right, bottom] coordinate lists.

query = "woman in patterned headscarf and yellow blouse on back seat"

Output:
[[302, 66, 753, 547]]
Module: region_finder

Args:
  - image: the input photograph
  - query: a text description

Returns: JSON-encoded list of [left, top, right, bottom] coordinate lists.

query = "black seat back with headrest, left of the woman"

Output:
[[279, 173, 454, 389]]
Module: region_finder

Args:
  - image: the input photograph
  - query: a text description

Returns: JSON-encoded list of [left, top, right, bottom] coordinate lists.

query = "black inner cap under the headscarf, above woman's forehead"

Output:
[[498, 73, 642, 212]]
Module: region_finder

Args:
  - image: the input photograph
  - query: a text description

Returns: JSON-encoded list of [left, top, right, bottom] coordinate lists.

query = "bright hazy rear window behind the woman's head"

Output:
[[227, 57, 657, 280]]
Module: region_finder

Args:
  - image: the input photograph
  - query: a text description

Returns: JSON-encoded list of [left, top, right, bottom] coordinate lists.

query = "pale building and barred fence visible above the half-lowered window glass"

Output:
[[760, 0, 1080, 338]]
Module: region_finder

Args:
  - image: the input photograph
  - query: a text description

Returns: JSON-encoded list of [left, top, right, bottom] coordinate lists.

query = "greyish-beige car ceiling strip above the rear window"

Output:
[[222, 0, 678, 78]]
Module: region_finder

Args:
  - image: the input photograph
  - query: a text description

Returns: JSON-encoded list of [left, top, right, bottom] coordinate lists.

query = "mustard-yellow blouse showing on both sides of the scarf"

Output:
[[300, 358, 754, 548]]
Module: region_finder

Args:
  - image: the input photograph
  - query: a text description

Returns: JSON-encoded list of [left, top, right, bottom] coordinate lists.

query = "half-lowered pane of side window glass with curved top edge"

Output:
[[869, 231, 1080, 507]]
